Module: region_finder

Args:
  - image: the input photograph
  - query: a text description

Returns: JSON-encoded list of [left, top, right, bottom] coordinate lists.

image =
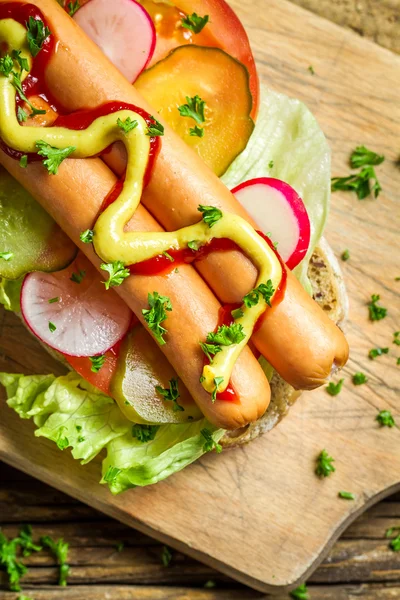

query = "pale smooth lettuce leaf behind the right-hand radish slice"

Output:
[[222, 86, 331, 294]]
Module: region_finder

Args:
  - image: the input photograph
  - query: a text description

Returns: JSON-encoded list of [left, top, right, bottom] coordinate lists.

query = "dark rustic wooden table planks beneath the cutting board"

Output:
[[0, 0, 400, 600]]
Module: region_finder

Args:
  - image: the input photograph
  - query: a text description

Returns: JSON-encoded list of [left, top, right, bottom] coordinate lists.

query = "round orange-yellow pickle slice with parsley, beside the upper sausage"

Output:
[[136, 46, 254, 175]]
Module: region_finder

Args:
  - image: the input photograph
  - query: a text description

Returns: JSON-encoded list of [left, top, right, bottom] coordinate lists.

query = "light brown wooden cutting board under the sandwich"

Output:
[[0, 0, 400, 592]]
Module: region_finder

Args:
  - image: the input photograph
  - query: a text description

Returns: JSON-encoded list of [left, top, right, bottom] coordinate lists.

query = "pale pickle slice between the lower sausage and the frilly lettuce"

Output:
[[110, 326, 203, 424]]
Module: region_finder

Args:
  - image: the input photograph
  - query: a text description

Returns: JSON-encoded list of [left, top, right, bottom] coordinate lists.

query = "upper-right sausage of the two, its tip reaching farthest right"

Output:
[[23, 0, 349, 389]]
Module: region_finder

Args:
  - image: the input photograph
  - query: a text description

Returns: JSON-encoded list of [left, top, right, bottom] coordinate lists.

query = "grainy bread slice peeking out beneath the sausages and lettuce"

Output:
[[220, 238, 349, 448]]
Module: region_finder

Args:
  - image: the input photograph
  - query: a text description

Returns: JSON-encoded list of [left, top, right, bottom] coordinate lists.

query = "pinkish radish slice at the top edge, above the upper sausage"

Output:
[[74, 0, 156, 83]]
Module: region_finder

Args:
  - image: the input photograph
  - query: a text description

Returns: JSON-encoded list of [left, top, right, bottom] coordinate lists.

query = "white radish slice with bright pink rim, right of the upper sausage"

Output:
[[232, 177, 310, 269]]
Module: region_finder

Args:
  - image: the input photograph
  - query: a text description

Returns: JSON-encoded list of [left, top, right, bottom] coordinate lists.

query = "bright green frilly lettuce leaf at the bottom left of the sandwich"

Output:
[[0, 372, 224, 494]]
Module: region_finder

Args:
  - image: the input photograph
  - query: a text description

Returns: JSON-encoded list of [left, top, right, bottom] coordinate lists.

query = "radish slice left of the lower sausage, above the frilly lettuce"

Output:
[[21, 255, 132, 356]]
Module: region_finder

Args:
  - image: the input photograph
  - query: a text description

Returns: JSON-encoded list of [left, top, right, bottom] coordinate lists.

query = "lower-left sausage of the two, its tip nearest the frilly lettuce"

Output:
[[0, 151, 270, 429]]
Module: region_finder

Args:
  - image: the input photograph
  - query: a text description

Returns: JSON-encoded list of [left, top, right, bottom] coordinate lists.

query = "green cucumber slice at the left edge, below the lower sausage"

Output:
[[0, 166, 77, 279]]
